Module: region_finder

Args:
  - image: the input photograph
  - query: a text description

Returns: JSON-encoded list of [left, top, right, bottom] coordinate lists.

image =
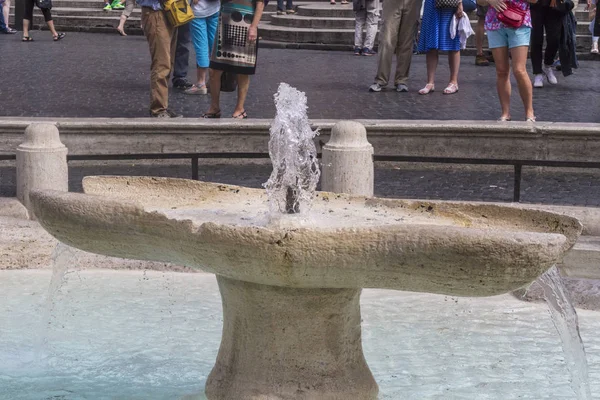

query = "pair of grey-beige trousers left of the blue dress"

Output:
[[375, 0, 421, 86]]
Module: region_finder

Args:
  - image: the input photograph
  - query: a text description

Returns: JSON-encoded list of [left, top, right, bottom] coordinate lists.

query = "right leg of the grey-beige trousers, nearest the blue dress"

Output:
[[392, 0, 420, 86]]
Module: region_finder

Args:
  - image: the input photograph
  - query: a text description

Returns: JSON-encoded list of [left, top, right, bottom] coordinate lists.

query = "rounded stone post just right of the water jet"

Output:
[[321, 121, 374, 197]]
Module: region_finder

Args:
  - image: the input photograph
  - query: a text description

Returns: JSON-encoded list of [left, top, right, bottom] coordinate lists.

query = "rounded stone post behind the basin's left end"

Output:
[[17, 123, 69, 219]]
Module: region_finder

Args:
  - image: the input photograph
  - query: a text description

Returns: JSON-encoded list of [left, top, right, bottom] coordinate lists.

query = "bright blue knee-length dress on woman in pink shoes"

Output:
[[418, 0, 466, 53]]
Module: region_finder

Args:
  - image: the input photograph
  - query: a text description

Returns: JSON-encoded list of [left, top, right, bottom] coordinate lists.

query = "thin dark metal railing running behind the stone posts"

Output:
[[0, 153, 600, 203]]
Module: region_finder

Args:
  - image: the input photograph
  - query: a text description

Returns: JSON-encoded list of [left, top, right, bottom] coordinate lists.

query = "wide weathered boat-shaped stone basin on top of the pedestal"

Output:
[[30, 176, 582, 296]]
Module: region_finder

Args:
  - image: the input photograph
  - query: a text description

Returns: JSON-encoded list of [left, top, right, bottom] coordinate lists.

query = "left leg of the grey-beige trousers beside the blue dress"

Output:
[[375, 0, 403, 87]]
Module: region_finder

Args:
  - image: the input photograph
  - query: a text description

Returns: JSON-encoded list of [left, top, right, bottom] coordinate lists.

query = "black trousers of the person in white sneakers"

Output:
[[531, 4, 563, 74]]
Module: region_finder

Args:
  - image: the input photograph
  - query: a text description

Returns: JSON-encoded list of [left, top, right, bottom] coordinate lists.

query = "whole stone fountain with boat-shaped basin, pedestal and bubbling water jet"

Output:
[[30, 86, 581, 400]]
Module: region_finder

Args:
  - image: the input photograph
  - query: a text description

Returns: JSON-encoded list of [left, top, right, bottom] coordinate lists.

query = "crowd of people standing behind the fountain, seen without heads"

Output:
[[0, 0, 600, 121]]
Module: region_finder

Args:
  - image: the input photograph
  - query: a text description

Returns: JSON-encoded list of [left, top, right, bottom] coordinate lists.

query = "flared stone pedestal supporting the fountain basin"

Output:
[[206, 276, 378, 400]]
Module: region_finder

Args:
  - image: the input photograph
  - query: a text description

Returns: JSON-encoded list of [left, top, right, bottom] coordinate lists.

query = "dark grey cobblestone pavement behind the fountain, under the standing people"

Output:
[[0, 32, 600, 122]]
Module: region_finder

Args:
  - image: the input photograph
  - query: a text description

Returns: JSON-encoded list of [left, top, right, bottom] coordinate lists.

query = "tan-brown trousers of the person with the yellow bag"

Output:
[[142, 7, 177, 114]]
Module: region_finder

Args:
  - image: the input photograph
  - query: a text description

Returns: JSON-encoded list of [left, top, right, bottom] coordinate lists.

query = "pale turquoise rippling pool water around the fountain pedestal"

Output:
[[0, 270, 600, 400]]
